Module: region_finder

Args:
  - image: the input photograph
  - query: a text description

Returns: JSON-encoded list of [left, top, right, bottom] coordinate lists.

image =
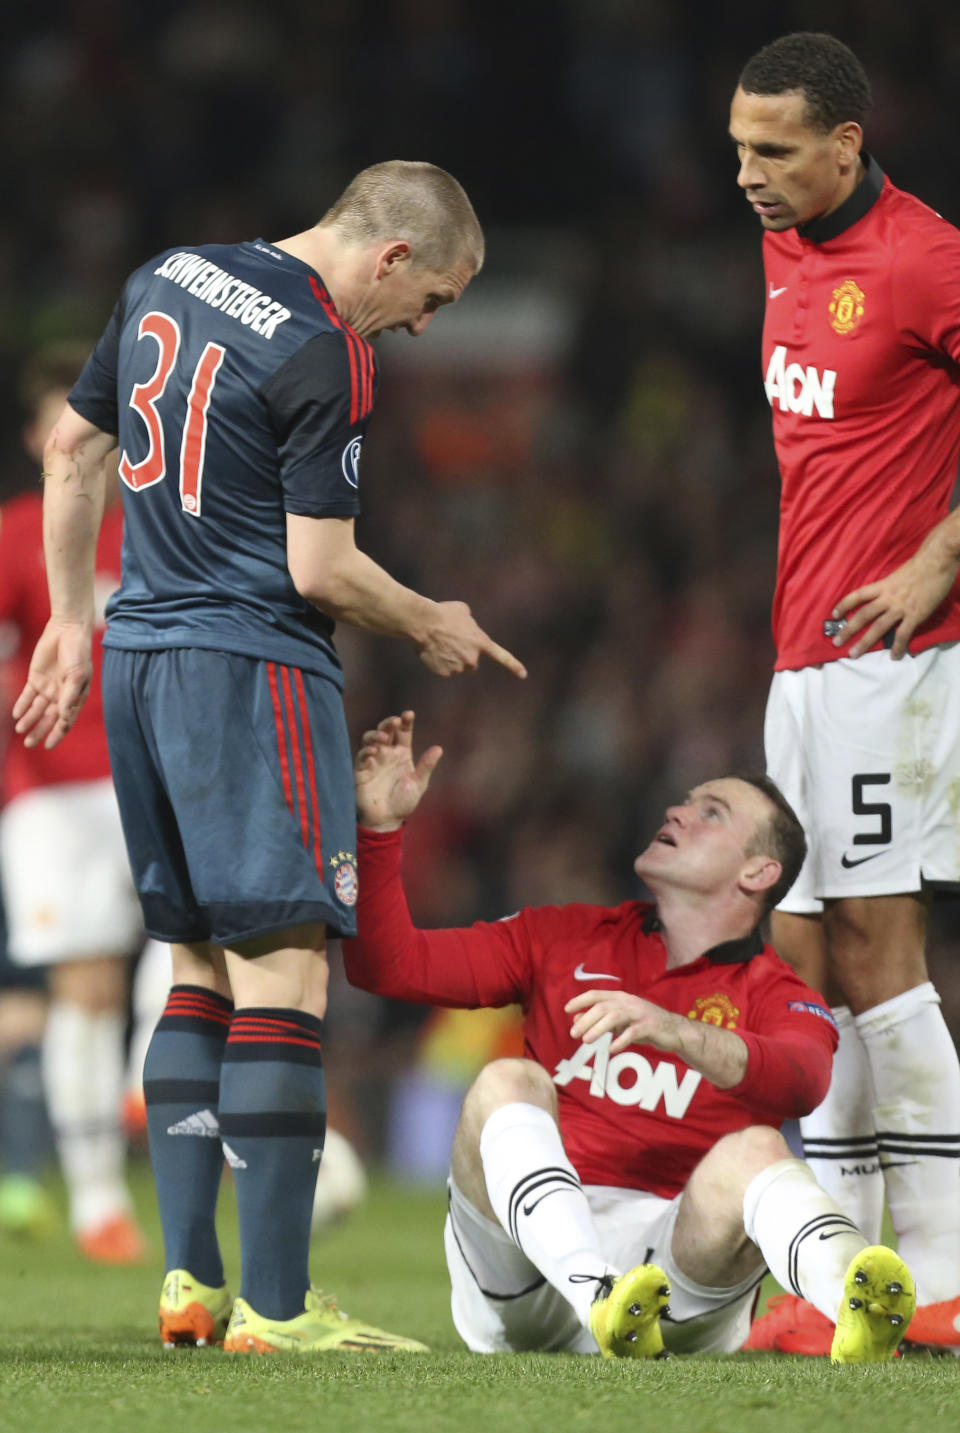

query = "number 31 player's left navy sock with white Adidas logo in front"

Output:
[[143, 984, 234, 1288]]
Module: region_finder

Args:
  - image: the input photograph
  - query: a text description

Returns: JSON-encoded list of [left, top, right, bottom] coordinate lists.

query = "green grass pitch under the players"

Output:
[[0, 1169, 960, 1433]]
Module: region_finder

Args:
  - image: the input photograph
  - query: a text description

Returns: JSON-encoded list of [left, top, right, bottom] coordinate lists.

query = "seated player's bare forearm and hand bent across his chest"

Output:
[[565, 990, 748, 1089]]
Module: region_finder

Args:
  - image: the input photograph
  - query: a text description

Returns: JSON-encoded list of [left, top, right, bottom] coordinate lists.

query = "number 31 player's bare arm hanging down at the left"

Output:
[[13, 404, 116, 749]]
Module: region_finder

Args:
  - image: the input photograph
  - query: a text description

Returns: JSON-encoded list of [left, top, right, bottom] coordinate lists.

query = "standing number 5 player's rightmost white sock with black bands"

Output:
[[854, 982, 960, 1304]]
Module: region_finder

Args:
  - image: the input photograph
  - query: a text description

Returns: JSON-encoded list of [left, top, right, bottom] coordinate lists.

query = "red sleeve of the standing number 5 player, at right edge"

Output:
[[893, 222, 960, 364]]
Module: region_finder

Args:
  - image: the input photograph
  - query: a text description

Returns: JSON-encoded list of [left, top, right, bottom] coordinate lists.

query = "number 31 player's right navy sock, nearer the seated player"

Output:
[[219, 1007, 327, 1320]]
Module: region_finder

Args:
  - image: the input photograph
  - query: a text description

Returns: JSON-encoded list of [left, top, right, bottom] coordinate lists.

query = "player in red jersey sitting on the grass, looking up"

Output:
[[344, 712, 913, 1363]]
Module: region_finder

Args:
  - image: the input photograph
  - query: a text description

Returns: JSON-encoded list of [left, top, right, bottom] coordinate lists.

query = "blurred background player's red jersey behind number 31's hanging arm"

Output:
[[0, 493, 123, 801]]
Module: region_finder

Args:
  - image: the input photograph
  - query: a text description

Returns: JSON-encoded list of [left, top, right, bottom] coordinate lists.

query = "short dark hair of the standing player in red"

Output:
[[739, 30, 873, 133]]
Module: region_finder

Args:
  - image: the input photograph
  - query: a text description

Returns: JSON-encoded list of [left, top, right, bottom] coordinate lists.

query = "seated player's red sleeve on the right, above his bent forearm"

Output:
[[728, 962, 838, 1123]]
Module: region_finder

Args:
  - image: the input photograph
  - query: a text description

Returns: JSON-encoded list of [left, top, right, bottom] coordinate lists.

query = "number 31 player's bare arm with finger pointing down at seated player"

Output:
[[287, 513, 527, 678]]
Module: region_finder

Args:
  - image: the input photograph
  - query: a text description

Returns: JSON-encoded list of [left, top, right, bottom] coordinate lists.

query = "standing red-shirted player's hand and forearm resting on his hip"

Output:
[[831, 509, 960, 662]]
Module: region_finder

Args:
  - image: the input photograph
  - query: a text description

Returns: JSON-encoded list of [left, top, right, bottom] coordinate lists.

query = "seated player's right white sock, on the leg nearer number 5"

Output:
[[744, 1159, 868, 1323]]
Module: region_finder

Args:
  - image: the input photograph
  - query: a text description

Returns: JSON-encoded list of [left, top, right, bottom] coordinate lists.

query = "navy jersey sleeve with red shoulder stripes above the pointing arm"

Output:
[[261, 330, 377, 517]]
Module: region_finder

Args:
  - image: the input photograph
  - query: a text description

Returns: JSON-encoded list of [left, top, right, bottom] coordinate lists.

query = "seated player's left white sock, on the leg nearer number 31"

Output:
[[480, 1101, 610, 1328]]
